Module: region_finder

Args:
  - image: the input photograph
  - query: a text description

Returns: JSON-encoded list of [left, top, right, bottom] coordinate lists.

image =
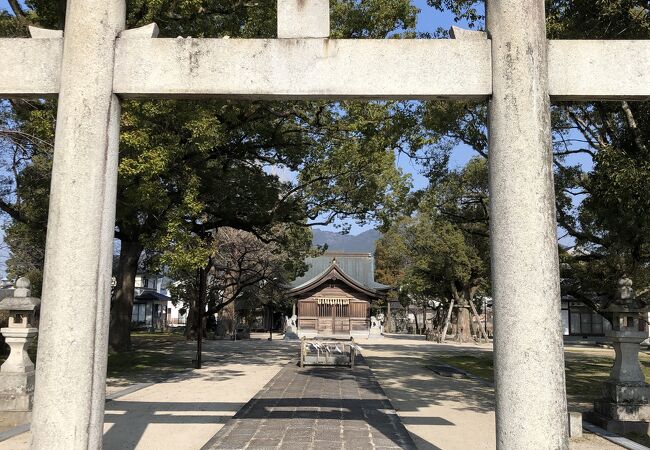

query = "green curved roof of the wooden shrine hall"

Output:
[[290, 253, 389, 291]]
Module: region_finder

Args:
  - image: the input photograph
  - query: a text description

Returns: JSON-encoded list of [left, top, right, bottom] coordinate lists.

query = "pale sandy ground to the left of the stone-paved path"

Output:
[[0, 341, 298, 450]]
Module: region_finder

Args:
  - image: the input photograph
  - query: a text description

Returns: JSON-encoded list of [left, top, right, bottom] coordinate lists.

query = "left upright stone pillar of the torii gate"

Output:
[[31, 0, 126, 450]]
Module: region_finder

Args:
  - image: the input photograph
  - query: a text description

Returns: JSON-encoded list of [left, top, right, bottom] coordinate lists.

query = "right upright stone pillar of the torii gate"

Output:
[[487, 0, 568, 449]]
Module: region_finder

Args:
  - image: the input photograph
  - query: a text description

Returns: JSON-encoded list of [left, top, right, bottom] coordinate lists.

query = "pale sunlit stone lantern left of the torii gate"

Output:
[[0, 278, 41, 422]]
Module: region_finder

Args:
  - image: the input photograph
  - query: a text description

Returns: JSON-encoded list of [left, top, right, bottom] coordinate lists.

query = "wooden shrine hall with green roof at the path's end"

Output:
[[288, 253, 389, 336]]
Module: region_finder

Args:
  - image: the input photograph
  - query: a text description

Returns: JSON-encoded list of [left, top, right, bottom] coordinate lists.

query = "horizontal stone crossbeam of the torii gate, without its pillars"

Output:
[[0, 29, 650, 101]]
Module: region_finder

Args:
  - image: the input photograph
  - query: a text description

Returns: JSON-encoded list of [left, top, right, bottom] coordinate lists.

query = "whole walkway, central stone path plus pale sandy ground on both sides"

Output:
[[0, 336, 620, 450]]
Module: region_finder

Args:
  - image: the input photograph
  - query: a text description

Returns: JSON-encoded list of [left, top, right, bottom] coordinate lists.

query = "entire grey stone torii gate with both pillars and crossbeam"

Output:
[[0, 0, 650, 450]]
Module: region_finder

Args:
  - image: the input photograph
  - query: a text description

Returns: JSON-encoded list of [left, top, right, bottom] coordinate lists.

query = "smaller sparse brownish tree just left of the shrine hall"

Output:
[[162, 225, 311, 338]]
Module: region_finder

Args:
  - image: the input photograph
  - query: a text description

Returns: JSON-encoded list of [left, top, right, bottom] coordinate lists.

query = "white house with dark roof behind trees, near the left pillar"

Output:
[[131, 273, 187, 331]]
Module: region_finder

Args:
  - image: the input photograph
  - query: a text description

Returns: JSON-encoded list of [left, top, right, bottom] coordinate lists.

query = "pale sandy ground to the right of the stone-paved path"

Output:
[[360, 335, 621, 450]]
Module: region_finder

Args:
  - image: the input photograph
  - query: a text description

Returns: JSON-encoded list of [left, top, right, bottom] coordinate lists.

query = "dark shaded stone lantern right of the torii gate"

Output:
[[587, 276, 650, 434]]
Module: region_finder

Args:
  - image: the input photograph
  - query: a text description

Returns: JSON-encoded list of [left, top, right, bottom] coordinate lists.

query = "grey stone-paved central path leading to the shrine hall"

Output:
[[203, 358, 416, 450]]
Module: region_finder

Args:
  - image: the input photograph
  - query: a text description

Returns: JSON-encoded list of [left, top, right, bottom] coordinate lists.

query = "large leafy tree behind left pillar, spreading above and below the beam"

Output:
[[0, 0, 416, 350]]
